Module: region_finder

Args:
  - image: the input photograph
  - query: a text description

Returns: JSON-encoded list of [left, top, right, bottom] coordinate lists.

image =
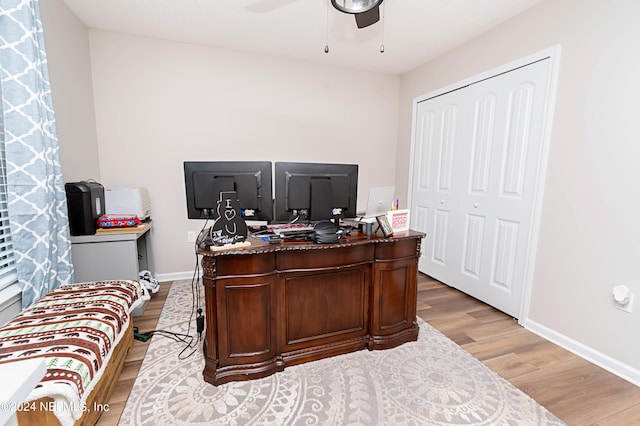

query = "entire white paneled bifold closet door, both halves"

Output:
[[411, 60, 550, 317]]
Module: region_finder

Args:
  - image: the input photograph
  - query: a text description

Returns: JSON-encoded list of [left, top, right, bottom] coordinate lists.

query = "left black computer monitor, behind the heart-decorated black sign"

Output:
[[184, 161, 273, 222]]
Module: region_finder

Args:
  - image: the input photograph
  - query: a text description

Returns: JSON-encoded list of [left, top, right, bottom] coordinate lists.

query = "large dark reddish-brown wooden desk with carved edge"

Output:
[[198, 231, 424, 385]]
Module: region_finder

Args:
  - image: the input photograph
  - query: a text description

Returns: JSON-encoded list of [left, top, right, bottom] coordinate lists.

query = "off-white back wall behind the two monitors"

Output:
[[90, 31, 399, 274]]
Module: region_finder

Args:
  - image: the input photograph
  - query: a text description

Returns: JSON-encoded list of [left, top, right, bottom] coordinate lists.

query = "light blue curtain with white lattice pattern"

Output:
[[0, 0, 73, 307]]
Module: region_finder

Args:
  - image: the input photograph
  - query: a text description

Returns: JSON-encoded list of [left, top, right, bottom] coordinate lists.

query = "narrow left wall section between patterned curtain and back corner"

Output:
[[39, 0, 100, 182]]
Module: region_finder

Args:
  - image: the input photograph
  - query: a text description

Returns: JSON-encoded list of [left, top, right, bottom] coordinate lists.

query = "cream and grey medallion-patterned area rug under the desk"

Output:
[[119, 281, 564, 426]]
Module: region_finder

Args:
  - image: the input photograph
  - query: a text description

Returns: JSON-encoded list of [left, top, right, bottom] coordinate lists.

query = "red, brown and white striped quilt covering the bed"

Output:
[[0, 280, 142, 424]]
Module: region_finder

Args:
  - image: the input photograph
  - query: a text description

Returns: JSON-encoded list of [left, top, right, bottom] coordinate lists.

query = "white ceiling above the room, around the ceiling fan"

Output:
[[63, 0, 542, 74]]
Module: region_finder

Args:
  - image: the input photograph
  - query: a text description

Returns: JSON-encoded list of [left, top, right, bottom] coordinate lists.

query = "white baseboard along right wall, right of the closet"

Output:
[[522, 320, 640, 386]]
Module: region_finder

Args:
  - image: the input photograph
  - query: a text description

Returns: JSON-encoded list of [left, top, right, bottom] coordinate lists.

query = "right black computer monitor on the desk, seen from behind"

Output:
[[274, 162, 358, 222]]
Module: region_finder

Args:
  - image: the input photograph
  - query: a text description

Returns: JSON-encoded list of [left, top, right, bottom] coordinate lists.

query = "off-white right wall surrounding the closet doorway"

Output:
[[396, 0, 640, 381]]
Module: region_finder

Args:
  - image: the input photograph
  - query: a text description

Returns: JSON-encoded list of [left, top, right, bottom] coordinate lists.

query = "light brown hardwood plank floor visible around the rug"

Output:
[[98, 274, 640, 426]]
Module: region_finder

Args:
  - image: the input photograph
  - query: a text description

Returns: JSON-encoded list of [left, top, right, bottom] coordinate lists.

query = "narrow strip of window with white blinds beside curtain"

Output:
[[0, 81, 18, 290]]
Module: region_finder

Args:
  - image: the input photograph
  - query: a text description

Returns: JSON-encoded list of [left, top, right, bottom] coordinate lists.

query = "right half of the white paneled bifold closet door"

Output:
[[450, 61, 548, 317]]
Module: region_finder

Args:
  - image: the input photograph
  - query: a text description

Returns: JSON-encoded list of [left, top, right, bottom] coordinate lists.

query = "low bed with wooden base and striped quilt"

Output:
[[0, 280, 143, 426]]
